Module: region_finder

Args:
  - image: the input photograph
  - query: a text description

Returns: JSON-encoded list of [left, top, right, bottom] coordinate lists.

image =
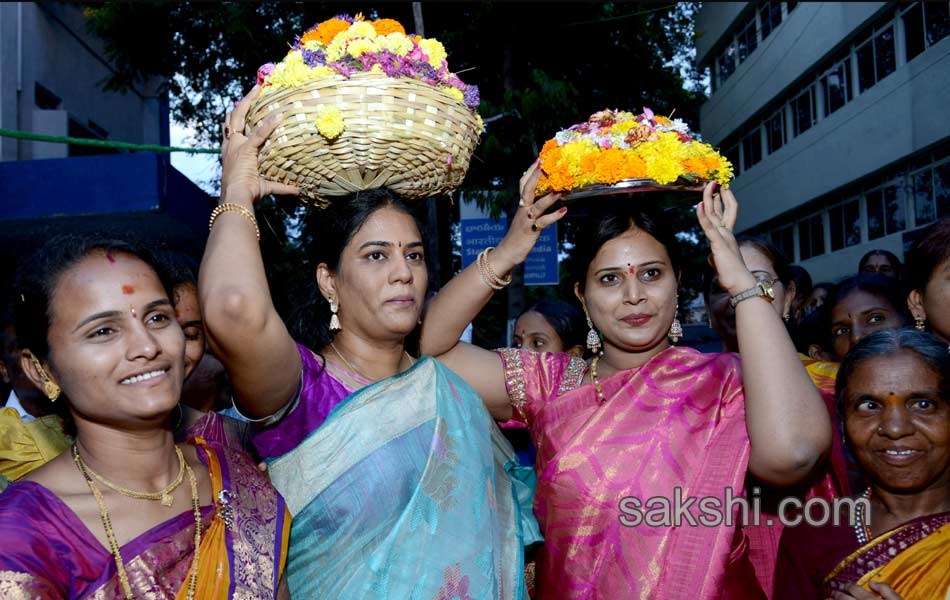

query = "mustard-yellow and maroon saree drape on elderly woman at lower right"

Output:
[[824, 513, 950, 600]]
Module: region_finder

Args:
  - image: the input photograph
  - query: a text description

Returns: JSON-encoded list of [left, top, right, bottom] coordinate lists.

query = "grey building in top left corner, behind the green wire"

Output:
[[0, 2, 168, 161]]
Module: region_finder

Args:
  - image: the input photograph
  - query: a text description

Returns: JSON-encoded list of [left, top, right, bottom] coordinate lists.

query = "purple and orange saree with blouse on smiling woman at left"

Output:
[[0, 438, 290, 600]]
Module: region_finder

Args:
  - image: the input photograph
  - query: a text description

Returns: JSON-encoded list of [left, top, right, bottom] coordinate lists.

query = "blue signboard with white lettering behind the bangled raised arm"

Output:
[[462, 217, 558, 285]]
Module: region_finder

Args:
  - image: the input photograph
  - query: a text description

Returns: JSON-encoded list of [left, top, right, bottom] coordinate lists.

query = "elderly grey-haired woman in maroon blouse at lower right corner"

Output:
[[775, 329, 950, 600]]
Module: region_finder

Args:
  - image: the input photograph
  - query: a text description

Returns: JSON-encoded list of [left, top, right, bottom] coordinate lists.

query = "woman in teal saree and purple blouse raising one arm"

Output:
[[199, 88, 536, 600]]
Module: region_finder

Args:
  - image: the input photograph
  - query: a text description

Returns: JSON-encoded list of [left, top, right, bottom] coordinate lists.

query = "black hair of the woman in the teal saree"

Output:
[[289, 188, 425, 351]]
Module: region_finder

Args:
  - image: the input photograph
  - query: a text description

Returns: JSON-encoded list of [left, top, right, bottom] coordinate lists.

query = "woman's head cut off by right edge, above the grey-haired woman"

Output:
[[907, 219, 950, 351]]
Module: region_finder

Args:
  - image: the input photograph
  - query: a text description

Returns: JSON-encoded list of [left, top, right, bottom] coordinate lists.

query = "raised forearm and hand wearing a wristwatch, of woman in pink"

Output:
[[696, 183, 831, 487]]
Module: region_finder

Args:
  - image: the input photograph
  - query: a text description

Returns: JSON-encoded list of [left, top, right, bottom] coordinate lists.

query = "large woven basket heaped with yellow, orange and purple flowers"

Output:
[[248, 15, 483, 207]]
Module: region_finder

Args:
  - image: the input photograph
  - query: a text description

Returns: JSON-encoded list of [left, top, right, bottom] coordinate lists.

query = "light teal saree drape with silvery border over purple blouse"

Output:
[[268, 357, 524, 600]]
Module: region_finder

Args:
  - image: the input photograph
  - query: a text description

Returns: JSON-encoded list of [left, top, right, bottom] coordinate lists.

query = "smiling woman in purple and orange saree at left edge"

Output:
[[0, 236, 290, 600]]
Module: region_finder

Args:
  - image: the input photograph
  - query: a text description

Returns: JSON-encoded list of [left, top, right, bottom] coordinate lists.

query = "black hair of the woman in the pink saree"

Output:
[[573, 200, 683, 291]]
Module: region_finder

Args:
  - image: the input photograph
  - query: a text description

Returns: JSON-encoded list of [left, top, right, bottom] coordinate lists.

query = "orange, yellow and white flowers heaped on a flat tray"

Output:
[[538, 108, 732, 194]]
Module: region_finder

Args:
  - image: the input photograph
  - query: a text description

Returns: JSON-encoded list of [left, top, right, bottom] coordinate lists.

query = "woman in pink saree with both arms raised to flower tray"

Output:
[[421, 166, 831, 600]]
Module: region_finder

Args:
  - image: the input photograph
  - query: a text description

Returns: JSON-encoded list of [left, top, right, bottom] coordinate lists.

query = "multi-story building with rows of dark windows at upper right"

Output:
[[696, 1, 950, 281]]
